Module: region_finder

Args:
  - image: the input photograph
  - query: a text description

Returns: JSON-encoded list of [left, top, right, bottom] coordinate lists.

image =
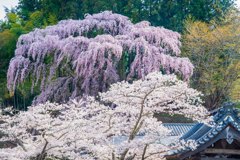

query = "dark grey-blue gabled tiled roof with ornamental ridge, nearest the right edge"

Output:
[[171, 104, 240, 158]]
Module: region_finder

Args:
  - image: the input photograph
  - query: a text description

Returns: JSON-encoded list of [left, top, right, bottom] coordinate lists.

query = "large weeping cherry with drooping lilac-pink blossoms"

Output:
[[7, 11, 193, 104]]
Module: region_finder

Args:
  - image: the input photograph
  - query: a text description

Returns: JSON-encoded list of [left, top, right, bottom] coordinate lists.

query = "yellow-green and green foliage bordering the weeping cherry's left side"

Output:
[[0, 11, 57, 109]]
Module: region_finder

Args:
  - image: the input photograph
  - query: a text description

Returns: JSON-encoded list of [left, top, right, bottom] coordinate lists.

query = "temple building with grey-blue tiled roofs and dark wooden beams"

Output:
[[165, 103, 240, 160]]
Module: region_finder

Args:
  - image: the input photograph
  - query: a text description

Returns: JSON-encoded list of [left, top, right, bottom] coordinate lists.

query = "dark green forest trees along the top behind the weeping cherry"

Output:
[[15, 0, 235, 31]]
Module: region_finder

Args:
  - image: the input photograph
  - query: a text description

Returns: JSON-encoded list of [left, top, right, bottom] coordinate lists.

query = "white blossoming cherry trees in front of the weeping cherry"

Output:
[[0, 72, 207, 160]]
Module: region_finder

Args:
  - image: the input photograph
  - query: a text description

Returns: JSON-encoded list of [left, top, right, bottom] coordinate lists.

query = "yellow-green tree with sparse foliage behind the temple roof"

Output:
[[183, 10, 240, 109]]
